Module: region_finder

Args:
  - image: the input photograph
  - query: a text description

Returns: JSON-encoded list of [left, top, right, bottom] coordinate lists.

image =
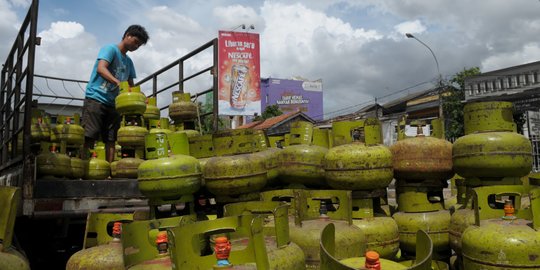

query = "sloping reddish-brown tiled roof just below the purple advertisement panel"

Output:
[[238, 111, 315, 136]]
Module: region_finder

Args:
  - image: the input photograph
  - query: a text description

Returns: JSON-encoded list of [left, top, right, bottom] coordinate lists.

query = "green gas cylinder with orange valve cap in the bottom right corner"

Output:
[[462, 185, 540, 270]]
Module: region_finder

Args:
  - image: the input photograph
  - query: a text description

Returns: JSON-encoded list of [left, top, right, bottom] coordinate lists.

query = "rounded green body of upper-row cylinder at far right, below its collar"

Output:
[[452, 132, 532, 178]]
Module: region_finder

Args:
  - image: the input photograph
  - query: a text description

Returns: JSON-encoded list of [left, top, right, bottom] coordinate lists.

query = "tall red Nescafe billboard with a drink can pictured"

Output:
[[218, 31, 261, 115]]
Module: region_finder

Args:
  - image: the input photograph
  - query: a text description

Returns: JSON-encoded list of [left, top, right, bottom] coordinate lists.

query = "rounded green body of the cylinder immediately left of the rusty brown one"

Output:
[[324, 142, 393, 190]]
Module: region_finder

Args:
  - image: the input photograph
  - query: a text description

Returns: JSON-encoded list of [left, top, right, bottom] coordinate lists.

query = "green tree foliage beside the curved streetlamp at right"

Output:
[[442, 67, 481, 138]]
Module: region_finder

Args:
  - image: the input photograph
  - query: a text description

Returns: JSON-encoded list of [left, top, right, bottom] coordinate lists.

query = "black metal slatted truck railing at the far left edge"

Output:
[[0, 0, 40, 186]]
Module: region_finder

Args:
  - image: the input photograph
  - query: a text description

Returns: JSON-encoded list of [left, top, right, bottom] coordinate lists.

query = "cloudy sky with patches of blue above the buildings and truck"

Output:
[[0, 0, 540, 119]]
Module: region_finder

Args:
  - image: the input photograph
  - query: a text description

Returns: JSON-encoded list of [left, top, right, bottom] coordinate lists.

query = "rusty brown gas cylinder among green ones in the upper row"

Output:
[[390, 125, 454, 182]]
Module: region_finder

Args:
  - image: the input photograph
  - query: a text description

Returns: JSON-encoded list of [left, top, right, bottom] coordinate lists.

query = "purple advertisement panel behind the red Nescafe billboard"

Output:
[[261, 78, 323, 120]]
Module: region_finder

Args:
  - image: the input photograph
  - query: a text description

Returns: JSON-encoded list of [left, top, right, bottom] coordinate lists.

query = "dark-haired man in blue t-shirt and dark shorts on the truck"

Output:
[[81, 25, 149, 162]]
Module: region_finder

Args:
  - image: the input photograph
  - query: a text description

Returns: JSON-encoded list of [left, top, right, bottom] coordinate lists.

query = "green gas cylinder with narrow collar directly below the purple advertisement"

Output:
[[278, 121, 328, 187]]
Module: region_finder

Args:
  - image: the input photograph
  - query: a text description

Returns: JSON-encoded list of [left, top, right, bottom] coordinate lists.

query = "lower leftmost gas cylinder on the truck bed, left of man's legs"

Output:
[[36, 142, 71, 178]]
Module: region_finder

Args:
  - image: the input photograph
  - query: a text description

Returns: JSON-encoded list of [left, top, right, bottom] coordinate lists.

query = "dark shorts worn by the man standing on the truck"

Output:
[[81, 98, 121, 142]]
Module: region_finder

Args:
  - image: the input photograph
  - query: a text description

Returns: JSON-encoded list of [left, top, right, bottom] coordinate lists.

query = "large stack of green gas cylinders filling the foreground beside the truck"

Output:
[[51, 92, 540, 269]]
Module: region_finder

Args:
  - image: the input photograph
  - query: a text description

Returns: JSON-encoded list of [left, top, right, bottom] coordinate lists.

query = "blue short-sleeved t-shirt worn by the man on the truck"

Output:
[[86, 44, 136, 107]]
